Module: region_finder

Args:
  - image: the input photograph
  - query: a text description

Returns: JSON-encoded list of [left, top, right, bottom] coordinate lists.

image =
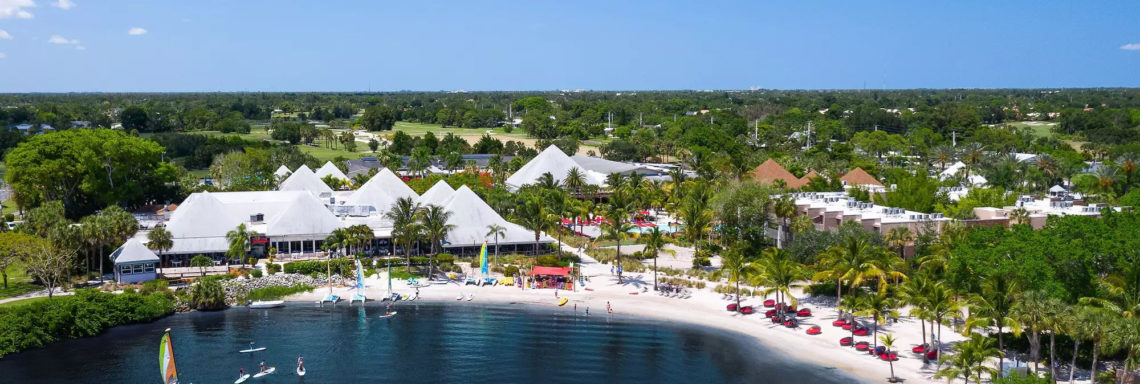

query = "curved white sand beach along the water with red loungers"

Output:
[[286, 249, 962, 383]]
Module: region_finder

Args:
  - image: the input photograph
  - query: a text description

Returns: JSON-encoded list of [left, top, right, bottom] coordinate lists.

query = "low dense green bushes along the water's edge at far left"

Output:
[[0, 289, 174, 356]]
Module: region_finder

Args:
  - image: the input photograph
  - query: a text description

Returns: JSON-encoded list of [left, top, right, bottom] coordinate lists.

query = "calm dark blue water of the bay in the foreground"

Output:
[[0, 303, 853, 384]]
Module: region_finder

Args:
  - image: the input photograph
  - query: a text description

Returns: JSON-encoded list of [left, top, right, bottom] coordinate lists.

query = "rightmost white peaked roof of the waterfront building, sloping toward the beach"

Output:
[[443, 186, 551, 246]]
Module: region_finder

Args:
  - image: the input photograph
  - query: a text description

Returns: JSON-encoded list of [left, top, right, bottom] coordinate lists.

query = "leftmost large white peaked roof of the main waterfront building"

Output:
[[166, 193, 242, 253]]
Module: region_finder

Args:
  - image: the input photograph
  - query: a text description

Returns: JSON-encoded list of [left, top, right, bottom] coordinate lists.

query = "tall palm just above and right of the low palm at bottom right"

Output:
[[964, 275, 1021, 377]]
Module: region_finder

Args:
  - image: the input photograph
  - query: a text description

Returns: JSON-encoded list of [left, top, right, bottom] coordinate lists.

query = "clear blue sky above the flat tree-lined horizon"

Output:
[[0, 0, 1140, 92]]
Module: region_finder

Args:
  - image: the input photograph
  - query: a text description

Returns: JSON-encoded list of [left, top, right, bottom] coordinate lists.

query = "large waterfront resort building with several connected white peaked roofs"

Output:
[[148, 166, 554, 265]]
